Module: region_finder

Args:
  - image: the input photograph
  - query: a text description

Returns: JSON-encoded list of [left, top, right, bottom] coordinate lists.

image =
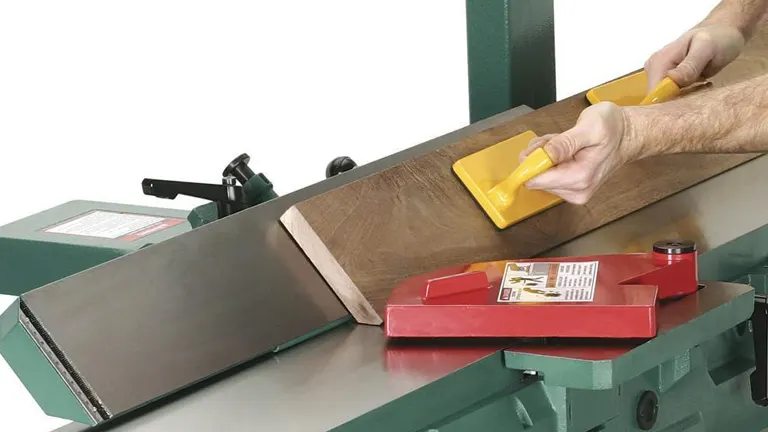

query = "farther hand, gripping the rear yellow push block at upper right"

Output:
[[644, 24, 745, 92]]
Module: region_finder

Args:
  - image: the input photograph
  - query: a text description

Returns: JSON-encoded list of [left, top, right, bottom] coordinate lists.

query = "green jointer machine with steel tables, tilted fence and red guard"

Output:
[[0, 98, 768, 432]]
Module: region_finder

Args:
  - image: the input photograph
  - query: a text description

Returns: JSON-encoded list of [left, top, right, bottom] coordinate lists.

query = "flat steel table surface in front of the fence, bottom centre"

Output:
[[57, 322, 502, 432]]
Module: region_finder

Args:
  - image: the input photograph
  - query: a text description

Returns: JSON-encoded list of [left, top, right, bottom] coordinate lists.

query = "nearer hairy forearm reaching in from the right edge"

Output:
[[621, 75, 768, 160]]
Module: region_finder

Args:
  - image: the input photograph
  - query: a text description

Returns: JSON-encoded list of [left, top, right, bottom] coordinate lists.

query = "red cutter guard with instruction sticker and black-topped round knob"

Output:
[[385, 241, 698, 338]]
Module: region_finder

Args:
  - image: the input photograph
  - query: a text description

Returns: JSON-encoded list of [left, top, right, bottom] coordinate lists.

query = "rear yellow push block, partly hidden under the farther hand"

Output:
[[587, 71, 681, 106]]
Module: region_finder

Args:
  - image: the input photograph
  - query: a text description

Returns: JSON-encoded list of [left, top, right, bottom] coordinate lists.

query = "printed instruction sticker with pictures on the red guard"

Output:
[[498, 261, 598, 303]]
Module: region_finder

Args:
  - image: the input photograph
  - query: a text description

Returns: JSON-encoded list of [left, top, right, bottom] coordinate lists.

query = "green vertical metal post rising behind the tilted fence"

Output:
[[466, 0, 557, 122]]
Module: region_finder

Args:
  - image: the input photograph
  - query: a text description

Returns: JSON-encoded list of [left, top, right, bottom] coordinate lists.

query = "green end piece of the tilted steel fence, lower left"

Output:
[[0, 299, 95, 425]]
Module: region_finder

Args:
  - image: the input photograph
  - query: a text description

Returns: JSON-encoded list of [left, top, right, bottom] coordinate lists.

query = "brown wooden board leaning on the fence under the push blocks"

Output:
[[281, 29, 768, 325]]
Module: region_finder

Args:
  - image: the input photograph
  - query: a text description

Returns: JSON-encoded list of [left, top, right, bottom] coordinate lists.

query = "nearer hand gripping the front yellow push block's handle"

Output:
[[520, 102, 634, 204]]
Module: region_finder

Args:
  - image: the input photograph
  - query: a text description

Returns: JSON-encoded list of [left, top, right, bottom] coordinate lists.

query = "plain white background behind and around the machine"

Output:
[[0, 0, 717, 432]]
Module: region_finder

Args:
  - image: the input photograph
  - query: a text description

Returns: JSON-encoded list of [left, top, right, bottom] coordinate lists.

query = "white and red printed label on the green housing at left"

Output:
[[43, 210, 184, 241]]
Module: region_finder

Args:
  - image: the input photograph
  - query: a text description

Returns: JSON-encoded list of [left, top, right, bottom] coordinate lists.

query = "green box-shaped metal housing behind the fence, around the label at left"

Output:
[[0, 201, 191, 296]]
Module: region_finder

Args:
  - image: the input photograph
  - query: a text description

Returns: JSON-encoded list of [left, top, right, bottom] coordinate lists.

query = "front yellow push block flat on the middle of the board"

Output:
[[453, 131, 562, 229]]
